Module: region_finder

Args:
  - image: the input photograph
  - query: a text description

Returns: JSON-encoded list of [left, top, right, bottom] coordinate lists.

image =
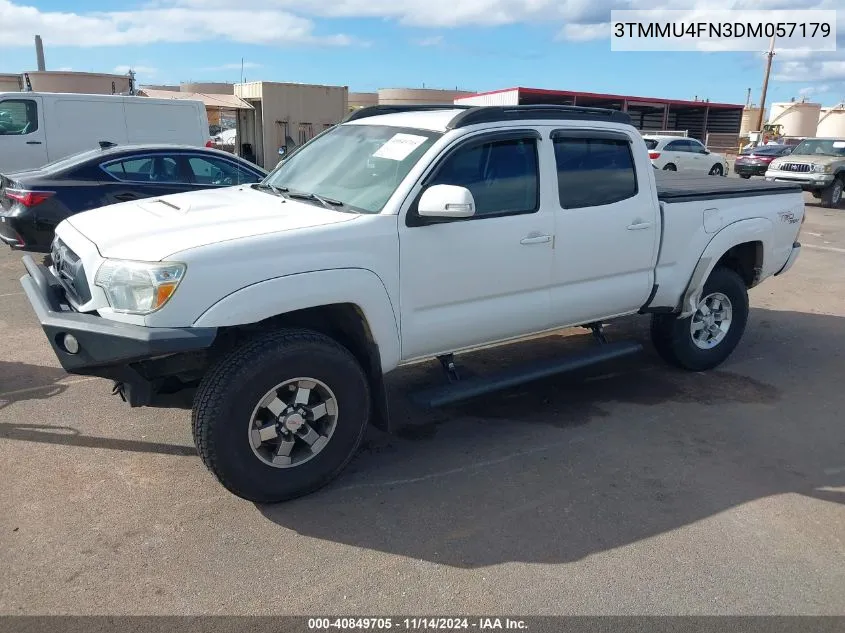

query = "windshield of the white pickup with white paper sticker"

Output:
[[262, 125, 442, 213]]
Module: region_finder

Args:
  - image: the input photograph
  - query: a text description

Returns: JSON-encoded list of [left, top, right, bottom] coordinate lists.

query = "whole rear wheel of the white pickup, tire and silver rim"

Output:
[[651, 267, 748, 371]]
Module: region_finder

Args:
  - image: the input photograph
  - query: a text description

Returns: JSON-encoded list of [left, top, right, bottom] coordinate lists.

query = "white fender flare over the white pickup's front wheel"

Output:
[[193, 268, 401, 373]]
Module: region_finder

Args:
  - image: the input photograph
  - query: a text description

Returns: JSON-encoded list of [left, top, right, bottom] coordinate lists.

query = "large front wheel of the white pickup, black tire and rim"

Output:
[[192, 330, 370, 503]]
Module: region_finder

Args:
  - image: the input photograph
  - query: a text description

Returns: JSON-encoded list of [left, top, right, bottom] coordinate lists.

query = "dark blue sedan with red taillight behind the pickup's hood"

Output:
[[0, 145, 267, 252]]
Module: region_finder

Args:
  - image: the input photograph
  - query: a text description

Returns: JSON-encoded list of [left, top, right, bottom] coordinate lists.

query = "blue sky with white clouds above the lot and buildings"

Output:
[[0, 0, 845, 105]]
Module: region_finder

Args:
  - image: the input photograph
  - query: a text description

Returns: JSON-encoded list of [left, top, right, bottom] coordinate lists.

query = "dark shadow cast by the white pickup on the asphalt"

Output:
[[259, 309, 845, 568]]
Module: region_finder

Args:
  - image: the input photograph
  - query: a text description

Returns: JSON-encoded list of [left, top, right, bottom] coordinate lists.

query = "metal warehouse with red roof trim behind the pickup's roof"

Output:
[[455, 88, 743, 145]]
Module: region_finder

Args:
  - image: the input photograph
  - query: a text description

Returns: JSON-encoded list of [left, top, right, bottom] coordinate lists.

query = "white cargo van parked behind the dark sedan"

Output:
[[0, 92, 211, 173]]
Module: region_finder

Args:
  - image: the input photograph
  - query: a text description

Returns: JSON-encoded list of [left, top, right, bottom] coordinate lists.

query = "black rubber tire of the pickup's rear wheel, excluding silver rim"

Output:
[[651, 266, 748, 371]]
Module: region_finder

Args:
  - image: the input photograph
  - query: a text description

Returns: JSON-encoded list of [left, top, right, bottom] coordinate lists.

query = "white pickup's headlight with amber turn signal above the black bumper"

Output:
[[94, 259, 185, 314]]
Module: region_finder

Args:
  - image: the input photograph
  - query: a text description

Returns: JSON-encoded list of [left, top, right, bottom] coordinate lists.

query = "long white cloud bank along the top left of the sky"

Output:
[[0, 0, 355, 48]]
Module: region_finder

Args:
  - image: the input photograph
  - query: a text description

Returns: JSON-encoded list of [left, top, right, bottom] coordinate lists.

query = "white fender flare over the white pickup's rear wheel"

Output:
[[678, 218, 773, 319]]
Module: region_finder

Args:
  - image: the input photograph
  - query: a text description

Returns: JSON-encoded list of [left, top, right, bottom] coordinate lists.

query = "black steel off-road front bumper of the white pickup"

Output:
[[20, 255, 217, 381]]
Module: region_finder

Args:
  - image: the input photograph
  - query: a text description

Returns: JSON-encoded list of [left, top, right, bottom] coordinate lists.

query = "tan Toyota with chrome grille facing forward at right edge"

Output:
[[766, 138, 845, 208]]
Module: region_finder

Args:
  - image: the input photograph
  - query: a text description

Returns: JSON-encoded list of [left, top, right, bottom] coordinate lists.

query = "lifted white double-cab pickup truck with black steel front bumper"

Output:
[[21, 106, 804, 502]]
